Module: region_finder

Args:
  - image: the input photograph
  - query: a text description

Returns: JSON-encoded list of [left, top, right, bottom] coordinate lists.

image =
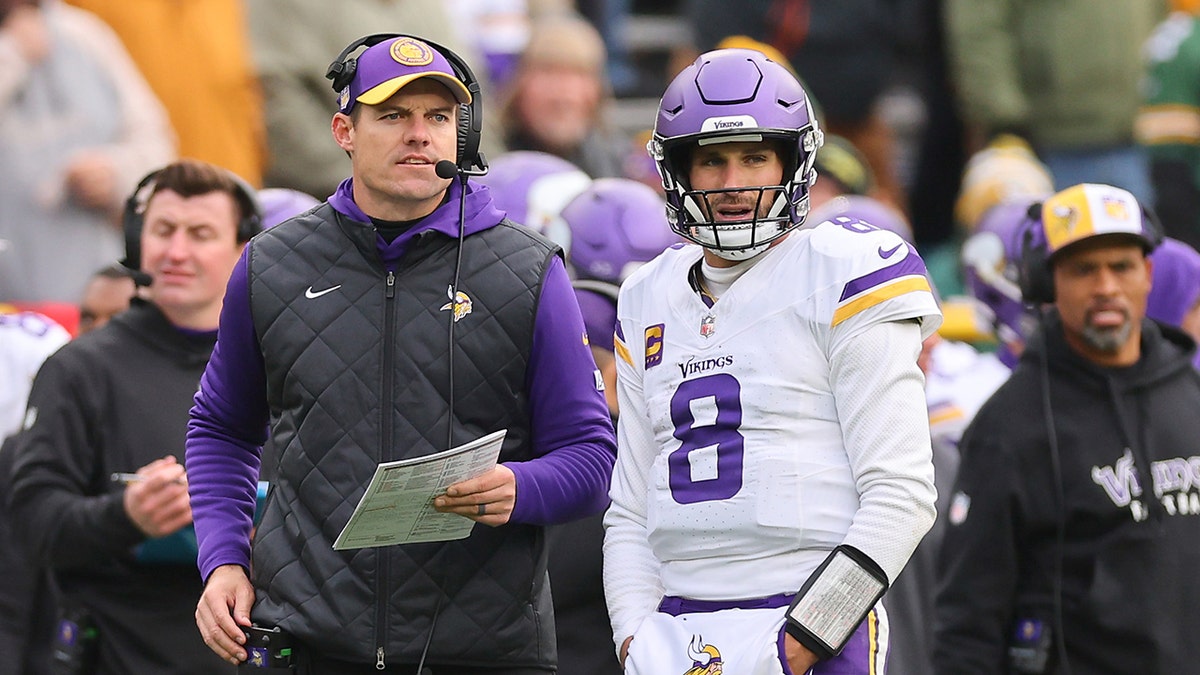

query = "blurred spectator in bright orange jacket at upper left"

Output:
[[67, 0, 266, 186]]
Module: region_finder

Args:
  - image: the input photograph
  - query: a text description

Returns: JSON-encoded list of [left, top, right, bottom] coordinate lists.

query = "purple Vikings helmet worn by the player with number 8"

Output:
[[646, 49, 823, 261]]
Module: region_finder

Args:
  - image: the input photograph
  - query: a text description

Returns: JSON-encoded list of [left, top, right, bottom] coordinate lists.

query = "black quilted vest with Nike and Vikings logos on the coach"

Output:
[[248, 204, 558, 665]]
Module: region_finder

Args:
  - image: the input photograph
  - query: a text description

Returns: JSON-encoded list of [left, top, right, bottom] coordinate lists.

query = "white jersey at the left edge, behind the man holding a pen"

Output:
[[0, 312, 71, 440]]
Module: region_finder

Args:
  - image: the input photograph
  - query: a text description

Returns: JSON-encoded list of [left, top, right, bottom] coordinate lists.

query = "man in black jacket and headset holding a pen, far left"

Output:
[[6, 160, 260, 675]]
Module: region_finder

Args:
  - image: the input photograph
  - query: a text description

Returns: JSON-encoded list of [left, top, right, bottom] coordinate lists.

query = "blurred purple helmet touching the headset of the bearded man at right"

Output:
[[961, 198, 1038, 368]]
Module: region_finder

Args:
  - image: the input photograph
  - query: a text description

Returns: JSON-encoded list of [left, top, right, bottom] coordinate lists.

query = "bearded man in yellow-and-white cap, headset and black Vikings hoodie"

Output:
[[934, 184, 1200, 674]]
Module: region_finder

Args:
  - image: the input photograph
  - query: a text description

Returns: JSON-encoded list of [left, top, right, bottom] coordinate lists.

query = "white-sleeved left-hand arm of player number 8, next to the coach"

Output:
[[604, 317, 662, 650]]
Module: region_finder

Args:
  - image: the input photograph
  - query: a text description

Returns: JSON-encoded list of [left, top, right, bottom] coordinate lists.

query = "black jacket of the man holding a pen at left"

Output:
[[11, 301, 233, 675]]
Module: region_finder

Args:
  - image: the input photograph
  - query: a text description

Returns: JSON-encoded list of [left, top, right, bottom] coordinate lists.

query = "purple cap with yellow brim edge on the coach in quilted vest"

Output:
[[337, 37, 470, 113]]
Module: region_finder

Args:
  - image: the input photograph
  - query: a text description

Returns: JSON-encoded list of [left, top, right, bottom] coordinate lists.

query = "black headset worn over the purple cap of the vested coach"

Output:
[[325, 32, 487, 178]]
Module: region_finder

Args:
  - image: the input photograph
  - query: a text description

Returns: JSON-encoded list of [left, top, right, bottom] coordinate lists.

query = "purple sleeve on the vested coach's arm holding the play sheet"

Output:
[[505, 258, 617, 525]]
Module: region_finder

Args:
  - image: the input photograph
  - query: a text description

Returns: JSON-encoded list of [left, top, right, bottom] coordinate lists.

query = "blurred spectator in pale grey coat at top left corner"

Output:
[[0, 0, 175, 300]]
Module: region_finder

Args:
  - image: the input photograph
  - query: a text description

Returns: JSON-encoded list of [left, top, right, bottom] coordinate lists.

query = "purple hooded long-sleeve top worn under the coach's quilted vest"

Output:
[[186, 180, 617, 579]]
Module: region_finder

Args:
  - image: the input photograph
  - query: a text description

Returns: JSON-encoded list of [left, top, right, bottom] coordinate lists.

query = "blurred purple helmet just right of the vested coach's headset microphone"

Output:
[[475, 150, 592, 250]]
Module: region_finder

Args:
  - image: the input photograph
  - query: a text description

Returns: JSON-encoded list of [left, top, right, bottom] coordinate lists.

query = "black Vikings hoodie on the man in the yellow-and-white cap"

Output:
[[934, 315, 1200, 675]]
